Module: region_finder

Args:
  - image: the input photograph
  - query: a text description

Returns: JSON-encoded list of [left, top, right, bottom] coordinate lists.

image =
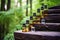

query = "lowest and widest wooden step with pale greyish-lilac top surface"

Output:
[[14, 30, 60, 40]]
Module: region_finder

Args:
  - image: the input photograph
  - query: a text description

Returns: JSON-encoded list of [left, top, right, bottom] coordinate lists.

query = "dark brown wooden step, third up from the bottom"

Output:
[[45, 15, 60, 23]]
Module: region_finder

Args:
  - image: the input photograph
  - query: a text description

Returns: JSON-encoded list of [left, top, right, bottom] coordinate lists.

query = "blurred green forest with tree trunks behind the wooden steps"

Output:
[[0, 0, 60, 40]]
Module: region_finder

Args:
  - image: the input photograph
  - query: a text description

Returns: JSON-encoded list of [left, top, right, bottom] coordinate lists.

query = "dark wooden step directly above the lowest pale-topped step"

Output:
[[30, 23, 60, 31]]
